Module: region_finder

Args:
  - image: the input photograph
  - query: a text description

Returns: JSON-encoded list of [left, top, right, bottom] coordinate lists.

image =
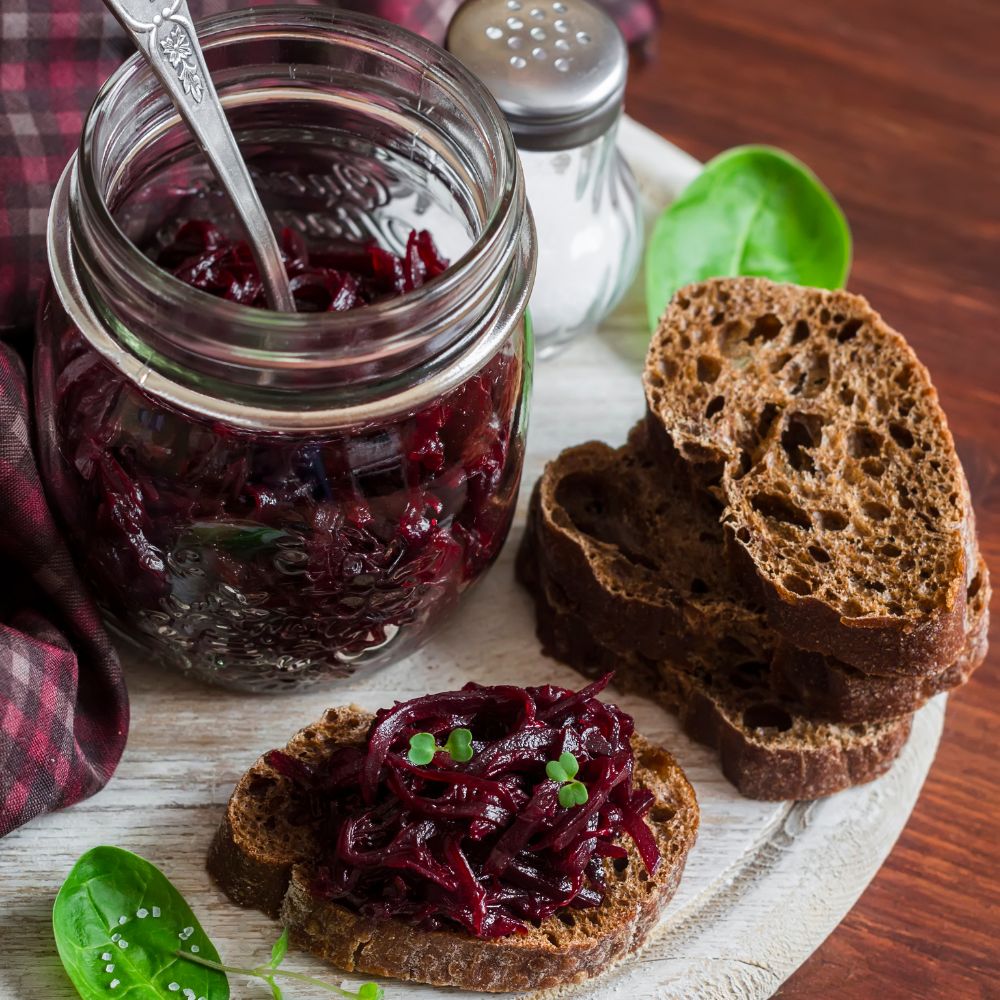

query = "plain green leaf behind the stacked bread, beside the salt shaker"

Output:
[[646, 146, 851, 329]]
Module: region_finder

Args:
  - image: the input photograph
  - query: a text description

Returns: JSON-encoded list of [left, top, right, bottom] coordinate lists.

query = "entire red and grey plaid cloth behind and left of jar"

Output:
[[0, 0, 655, 837]]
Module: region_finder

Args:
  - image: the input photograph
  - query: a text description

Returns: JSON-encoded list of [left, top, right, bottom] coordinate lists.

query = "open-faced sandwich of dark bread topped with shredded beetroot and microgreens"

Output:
[[208, 676, 698, 992]]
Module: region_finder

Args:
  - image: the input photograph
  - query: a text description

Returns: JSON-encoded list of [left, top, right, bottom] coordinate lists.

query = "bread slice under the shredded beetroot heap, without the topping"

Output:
[[208, 706, 698, 992]]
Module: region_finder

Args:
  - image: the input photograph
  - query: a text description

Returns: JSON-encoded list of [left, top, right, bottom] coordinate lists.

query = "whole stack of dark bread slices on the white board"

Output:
[[518, 278, 990, 799]]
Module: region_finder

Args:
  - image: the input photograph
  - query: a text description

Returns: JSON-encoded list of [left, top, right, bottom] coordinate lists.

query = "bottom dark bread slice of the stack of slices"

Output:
[[522, 548, 912, 801]]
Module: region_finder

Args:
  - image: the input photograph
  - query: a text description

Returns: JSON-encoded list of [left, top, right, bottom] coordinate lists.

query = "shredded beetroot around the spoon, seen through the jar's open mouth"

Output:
[[155, 219, 448, 312]]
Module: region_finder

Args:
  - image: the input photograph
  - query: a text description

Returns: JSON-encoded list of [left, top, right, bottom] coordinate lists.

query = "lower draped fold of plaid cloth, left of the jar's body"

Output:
[[0, 344, 128, 837]]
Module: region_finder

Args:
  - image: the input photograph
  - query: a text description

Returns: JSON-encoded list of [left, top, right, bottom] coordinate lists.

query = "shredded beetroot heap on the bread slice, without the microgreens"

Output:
[[267, 674, 660, 938]]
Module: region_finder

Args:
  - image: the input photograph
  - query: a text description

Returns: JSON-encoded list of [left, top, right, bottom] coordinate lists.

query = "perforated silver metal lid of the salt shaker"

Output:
[[445, 0, 628, 150]]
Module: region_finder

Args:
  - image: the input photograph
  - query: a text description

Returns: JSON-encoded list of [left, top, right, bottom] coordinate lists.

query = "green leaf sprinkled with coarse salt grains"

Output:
[[52, 847, 229, 1000]]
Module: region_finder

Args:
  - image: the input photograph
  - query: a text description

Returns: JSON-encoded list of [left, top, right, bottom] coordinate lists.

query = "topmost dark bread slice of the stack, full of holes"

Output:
[[643, 278, 974, 674]]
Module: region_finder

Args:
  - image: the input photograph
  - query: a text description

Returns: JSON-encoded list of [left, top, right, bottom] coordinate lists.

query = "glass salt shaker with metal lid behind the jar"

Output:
[[446, 0, 642, 357]]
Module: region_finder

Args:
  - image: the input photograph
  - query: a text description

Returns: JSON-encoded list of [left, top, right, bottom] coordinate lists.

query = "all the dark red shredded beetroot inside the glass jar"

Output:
[[43, 221, 523, 688]]
